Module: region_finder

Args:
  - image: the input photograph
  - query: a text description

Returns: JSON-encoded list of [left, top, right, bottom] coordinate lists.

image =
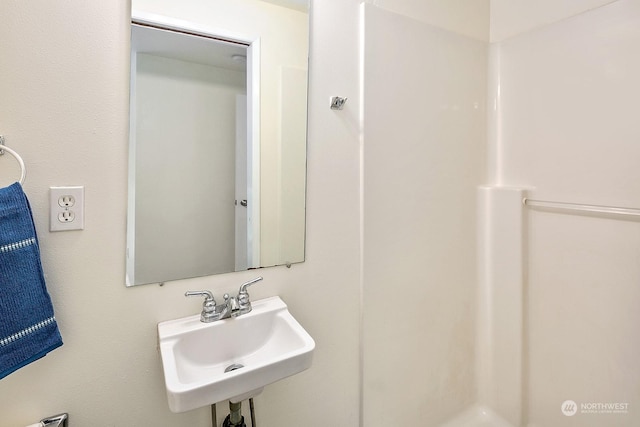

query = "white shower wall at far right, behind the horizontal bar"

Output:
[[492, 0, 640, 427]]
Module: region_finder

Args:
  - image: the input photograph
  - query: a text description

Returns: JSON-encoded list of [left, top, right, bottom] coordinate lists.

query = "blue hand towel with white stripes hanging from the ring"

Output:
[[0, 182, 62, 378]]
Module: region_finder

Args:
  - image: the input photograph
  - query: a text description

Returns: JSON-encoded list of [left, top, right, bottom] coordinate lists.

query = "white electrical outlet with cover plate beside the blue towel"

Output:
[[49, 186, 84, 231]]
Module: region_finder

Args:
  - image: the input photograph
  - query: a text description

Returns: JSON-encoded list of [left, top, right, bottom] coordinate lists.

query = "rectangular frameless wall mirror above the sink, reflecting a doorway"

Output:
[[126, 0, 309, 286]]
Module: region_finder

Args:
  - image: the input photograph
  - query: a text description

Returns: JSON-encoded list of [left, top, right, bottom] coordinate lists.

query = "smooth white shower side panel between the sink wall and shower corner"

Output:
[[362, 5, 487, 427]]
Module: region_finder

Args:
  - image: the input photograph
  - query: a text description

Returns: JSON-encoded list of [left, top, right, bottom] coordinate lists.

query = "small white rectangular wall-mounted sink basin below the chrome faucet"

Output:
[[158, 297, 315, 412]]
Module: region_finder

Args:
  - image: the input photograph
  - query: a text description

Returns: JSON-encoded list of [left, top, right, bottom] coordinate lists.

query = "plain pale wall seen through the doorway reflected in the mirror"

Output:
[[134, 54, 247, 284]]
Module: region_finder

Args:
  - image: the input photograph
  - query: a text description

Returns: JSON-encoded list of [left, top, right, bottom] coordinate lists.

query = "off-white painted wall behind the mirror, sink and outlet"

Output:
[[0, 0, 359, 427]]
